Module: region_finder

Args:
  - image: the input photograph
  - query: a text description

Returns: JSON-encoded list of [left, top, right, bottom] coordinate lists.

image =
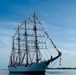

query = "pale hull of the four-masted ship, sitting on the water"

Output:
[[8, 62, 47, 73]]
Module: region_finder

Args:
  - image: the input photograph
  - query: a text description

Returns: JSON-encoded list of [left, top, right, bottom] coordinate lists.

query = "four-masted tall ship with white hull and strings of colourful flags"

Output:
[[8, 13, 62, 73]]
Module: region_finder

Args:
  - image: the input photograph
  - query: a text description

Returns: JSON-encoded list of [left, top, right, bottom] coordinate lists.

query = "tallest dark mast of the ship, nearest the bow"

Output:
[[34, 12, 38, 63]]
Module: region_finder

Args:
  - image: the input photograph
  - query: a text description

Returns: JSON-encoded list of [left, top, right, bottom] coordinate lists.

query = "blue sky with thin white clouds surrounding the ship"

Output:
[[0, 0, 76, 68]]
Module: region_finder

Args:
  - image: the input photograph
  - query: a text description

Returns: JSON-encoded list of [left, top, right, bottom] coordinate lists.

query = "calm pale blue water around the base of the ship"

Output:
[[0, 70, 76, 75]]
